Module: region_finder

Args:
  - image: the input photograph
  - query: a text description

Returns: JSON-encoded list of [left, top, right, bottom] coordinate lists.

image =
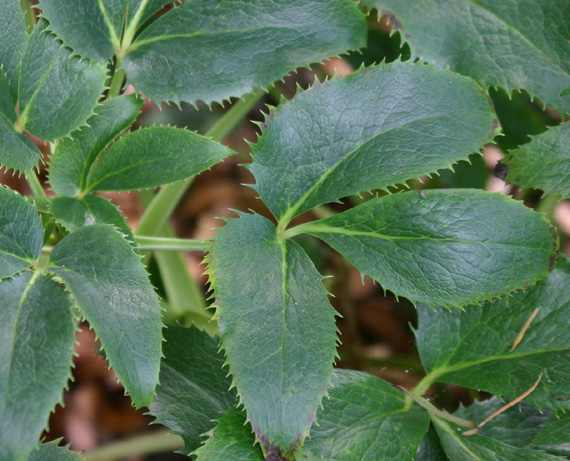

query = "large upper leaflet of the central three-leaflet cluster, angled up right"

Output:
[[246, 62, 498, 224]]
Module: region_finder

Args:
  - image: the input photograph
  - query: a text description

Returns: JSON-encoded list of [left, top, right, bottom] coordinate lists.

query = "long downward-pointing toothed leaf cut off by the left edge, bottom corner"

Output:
[[0, 271, 75, 461]]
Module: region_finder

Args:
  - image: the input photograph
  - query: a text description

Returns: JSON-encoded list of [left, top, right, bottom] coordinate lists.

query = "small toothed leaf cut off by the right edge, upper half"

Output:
[[501, 123, 570, 199]]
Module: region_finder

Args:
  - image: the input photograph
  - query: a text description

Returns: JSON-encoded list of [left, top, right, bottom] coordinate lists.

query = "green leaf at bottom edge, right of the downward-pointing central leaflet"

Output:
[[298, 370, 429, 461]]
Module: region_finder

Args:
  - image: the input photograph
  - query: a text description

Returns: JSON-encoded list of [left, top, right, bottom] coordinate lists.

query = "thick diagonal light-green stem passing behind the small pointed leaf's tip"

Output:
[[137, 90, 265, 235]]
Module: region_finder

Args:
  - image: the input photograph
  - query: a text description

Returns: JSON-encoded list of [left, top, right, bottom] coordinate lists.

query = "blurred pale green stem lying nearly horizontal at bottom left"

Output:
[[83, 431, 184, 461]]
